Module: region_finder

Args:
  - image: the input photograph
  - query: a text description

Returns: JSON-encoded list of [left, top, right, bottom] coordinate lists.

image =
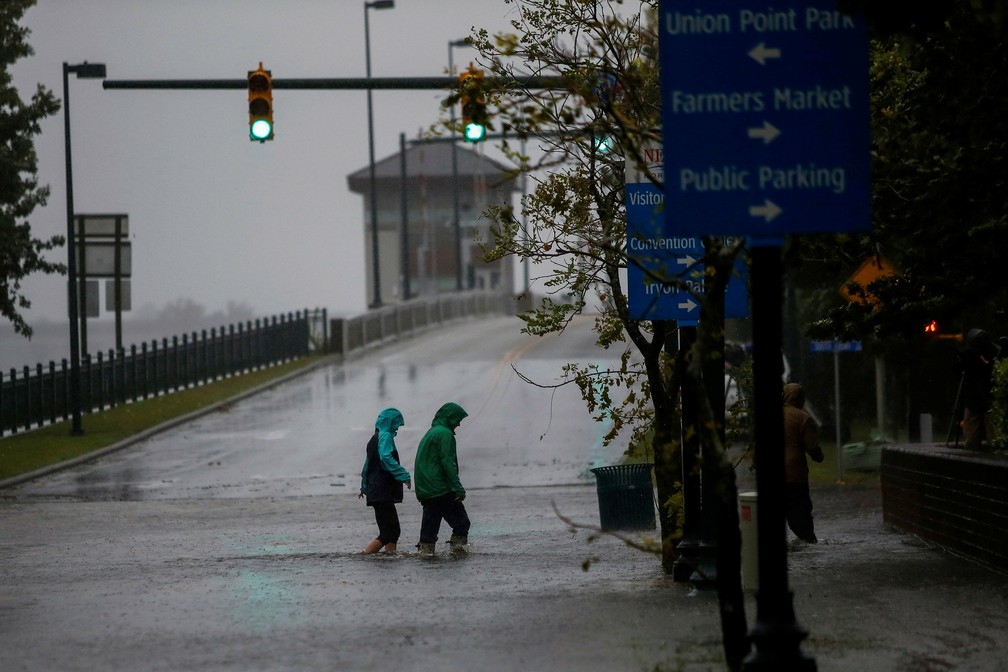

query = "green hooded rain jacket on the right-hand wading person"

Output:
[[413, 401, 469, 502]]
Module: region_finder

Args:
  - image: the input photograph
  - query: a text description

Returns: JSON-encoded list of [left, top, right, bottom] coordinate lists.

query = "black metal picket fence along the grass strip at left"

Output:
[[0, 309, 320, 435]]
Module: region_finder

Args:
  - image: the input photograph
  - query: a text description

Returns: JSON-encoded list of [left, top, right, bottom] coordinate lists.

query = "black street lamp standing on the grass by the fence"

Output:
[[64, 61, 105, 436]]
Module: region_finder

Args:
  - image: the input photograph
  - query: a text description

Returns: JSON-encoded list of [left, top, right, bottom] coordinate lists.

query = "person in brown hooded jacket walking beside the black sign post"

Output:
[[783, 383, 824, 544]]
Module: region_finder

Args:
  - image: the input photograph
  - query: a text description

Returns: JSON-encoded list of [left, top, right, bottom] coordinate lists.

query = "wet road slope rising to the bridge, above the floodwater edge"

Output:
[[13, 317, 625, 500]]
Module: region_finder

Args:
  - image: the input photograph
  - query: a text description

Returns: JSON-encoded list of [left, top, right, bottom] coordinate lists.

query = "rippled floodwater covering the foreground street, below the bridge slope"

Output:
[[0, 475, 1008, 672]]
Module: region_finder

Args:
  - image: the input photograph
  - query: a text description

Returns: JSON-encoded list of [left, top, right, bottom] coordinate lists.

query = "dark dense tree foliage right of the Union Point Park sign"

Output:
[[796, 0, 1008, 341]]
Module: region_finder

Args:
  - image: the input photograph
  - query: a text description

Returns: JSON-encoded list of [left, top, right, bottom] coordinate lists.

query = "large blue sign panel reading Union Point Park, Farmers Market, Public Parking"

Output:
[[659, 0, 871, 238]]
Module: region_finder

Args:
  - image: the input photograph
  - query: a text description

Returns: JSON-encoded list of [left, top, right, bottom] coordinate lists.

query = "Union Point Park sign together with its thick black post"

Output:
[[658, 0, 871, 672]]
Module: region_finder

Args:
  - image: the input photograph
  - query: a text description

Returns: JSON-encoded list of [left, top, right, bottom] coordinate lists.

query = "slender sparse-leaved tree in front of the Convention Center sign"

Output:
[[463, 0, 748, 669]]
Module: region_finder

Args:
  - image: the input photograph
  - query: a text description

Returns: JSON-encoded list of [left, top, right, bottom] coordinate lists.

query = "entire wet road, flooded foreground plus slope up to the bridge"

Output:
[[0, 319, 1008, 672]]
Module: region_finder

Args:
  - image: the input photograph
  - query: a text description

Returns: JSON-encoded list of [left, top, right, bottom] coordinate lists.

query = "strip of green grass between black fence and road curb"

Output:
[[0, 357, 322, 481]]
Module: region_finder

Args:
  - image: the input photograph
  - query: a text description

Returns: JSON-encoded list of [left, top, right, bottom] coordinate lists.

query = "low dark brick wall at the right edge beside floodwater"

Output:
[[881, 444, 1008, 571]]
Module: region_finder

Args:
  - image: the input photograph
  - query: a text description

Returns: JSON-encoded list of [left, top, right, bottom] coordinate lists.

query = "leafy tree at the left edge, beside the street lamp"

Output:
[[0, 0, 67, 338]]
